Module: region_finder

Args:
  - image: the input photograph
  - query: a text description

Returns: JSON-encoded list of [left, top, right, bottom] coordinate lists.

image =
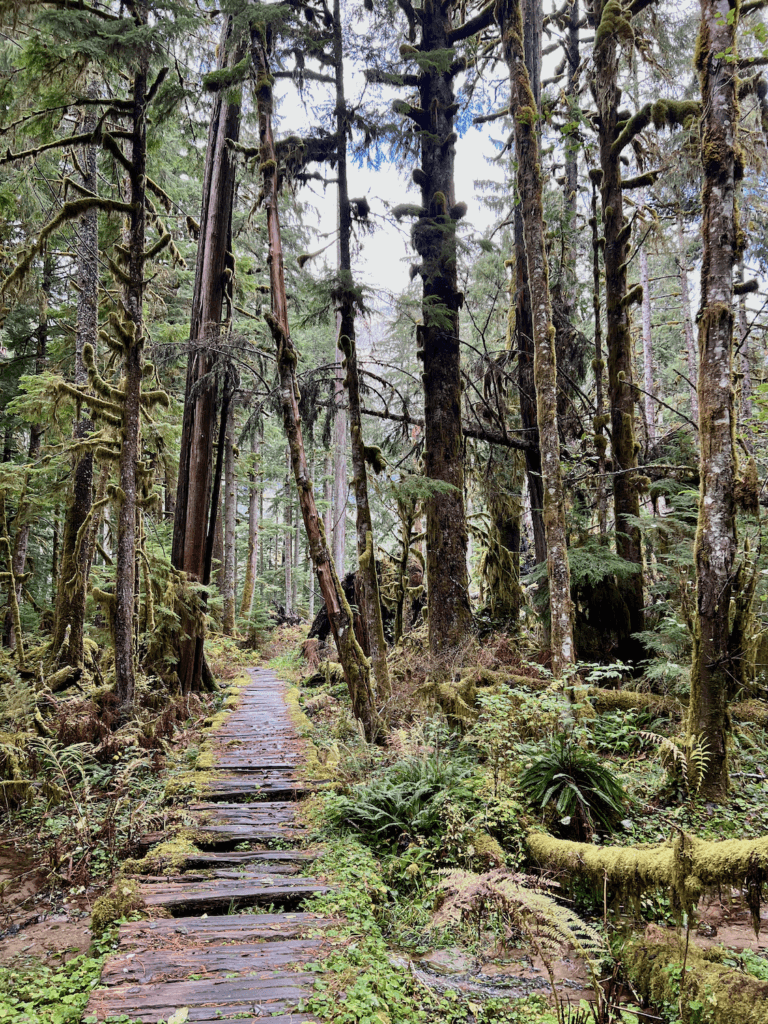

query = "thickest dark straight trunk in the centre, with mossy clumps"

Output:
[[395, 0, 493, 655]]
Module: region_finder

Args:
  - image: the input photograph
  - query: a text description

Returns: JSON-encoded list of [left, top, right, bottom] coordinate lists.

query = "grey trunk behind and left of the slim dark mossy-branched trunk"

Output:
[[51, 99, 98, 667]]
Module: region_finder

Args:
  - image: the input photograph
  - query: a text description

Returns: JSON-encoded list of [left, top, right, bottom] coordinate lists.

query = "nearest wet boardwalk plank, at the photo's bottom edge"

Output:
[[88, 971, 313, 1024]]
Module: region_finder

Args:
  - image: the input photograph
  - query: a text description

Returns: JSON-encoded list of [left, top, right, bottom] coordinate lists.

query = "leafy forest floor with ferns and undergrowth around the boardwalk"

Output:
[[0, 628, 768, 1024]]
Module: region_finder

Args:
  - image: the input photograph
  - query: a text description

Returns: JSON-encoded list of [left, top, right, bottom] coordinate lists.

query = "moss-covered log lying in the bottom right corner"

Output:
[[622, 925, 768, 1024]]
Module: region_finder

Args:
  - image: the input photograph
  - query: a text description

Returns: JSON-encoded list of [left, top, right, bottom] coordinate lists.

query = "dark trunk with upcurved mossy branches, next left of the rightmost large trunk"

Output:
[[593, 0, 645, 663]]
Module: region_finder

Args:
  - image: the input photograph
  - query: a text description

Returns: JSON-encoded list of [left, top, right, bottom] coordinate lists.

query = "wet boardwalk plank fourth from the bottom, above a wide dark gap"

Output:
[[138, 874, 330, 913]]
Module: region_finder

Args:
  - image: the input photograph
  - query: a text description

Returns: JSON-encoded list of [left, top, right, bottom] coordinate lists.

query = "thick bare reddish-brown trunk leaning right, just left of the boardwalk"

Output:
[[171, 16, 246, 693]]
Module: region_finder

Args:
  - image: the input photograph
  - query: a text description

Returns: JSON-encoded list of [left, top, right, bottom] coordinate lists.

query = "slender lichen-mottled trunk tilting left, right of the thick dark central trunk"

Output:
[[497, 0, 574, 678]]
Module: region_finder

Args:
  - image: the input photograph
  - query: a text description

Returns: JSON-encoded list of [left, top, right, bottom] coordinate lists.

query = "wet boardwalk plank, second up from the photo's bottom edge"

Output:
[[101, 939, 323, 986]]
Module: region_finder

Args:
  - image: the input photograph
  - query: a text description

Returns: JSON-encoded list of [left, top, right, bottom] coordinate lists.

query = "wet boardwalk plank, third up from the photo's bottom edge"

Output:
[[119, 913, 336, 950]]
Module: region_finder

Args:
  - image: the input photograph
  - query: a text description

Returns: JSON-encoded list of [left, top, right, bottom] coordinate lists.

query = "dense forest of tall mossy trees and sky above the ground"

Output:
[[0, 0, 768, 1015]]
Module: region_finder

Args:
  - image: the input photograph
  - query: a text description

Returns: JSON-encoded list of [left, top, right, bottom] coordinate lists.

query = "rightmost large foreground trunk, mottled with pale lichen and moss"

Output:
[[688, 0, 739, 800]]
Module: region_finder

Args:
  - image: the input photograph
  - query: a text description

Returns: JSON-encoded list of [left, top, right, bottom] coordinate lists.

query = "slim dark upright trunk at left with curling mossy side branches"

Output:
[[115, 36, 148, 718]]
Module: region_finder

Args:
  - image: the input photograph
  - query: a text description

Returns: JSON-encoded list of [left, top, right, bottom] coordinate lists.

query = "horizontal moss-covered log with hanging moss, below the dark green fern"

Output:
[[527, 831, 768, 934]]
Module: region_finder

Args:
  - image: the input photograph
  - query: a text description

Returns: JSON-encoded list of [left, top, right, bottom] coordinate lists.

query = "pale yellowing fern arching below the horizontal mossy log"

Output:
[[432, 869, 610, 1024]]
